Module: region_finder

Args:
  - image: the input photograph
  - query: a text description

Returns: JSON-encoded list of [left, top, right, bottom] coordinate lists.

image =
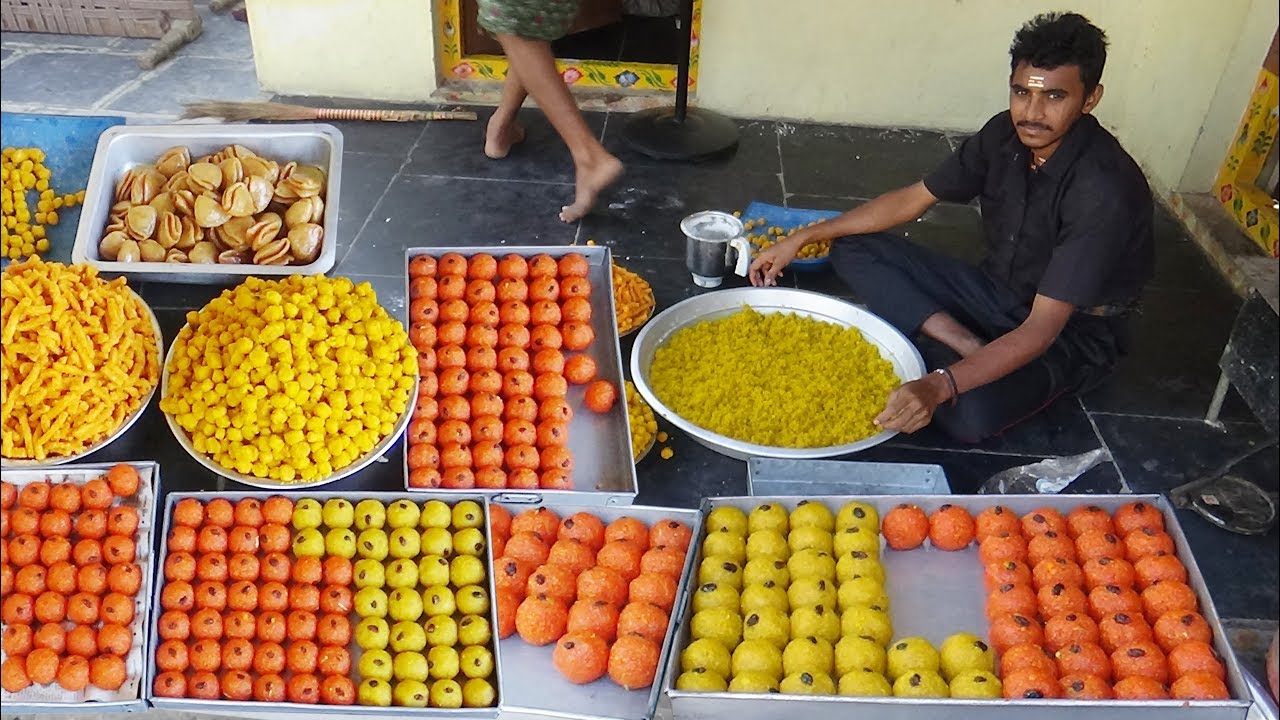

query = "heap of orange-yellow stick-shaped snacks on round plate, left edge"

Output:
[[0, 258, 160, 460]]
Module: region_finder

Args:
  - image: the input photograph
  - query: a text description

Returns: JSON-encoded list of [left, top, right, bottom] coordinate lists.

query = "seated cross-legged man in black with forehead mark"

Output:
[[750, 13, 1155, 442]]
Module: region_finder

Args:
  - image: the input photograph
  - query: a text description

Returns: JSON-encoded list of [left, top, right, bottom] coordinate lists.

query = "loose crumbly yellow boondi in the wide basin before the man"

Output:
[[649, 307, 900, 447]]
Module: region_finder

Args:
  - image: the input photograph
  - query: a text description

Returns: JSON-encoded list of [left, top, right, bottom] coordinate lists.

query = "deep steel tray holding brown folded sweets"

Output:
[[72, 123, 342, 284]]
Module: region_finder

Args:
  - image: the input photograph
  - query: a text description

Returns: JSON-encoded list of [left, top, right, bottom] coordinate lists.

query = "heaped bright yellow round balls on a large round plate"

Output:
[[160, 275, 417, 483]]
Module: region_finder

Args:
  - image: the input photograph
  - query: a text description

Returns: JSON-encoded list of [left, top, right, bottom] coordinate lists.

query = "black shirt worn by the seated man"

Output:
[[924, 111, 1155, 315]]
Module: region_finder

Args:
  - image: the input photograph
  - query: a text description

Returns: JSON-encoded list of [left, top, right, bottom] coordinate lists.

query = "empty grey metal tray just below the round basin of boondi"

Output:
[[746, 457, 951, 496]]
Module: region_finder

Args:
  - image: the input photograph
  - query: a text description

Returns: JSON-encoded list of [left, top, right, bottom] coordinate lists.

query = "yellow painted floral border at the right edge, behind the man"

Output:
[[1213, 68, 1280, 258]]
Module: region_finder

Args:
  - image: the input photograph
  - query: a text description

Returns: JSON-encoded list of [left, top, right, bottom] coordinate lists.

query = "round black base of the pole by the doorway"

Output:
[[622, 108, 737, 160]]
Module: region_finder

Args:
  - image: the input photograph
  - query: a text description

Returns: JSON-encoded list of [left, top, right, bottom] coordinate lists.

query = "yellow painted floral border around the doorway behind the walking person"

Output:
[[435, 0, 703, 92]]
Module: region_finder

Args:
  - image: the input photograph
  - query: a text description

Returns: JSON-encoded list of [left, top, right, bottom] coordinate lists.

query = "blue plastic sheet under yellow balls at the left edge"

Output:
[[0, 113, 124, 265]]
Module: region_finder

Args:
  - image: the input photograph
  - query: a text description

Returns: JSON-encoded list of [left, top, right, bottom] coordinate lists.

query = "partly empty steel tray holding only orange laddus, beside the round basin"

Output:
[[403, 245, 639, 505]]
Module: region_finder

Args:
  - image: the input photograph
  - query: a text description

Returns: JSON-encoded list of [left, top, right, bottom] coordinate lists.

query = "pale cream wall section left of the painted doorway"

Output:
[[246, 0, 436, 101]]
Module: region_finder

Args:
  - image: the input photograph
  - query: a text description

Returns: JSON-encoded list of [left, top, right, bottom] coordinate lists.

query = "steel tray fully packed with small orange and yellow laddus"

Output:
[[143, 491, 504, 719]]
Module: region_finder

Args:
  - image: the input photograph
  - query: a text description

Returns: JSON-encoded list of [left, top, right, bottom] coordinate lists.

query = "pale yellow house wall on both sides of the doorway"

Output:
[[238, 0, 1277, 195]]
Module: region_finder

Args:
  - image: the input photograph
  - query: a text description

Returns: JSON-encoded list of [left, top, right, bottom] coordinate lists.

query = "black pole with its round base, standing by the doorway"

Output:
[[622, 0, 737, 160]]
